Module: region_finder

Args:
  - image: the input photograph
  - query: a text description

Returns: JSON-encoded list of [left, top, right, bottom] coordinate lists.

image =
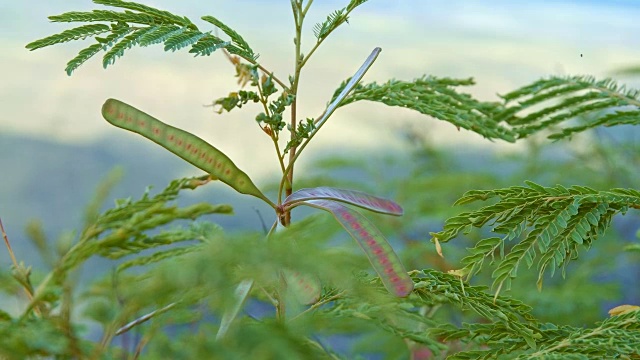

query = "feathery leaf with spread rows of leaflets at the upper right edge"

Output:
[[495, 76, 640, 139]]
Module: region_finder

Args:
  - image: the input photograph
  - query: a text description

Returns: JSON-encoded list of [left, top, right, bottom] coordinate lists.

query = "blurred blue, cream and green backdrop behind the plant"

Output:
[[0, 0, 640, 338]]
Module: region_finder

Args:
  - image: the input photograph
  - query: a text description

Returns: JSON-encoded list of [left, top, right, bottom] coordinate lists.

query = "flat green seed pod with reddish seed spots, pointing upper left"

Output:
[[102, 99, 275, 206]]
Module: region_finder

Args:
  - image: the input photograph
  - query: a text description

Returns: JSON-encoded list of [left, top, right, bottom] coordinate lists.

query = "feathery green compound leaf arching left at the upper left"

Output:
[[26, 0, 258, 75]]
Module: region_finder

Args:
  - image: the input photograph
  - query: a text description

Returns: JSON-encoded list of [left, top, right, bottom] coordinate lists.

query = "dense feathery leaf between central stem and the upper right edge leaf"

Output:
[[334, 76, 517, 142]]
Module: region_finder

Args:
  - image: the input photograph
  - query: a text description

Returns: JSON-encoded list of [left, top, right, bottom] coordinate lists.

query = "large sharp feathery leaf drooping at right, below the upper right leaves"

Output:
[[431, 182, 640, 289]]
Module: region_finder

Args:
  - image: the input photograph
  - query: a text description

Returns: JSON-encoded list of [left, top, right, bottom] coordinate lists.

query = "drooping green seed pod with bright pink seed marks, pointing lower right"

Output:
[[302, 200, 413, 297]]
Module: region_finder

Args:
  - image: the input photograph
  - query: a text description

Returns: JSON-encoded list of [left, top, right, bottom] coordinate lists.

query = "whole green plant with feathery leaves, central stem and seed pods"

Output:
[[0, 0, 640, 359]]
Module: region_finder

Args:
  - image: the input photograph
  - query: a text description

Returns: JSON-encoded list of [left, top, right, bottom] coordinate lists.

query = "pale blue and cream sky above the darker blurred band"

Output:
[[0, 0, 640, 176]]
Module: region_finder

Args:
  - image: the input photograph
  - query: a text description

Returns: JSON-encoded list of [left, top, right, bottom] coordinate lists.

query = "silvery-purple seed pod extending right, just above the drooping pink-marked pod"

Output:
[[282, 186, 403, 216]]
